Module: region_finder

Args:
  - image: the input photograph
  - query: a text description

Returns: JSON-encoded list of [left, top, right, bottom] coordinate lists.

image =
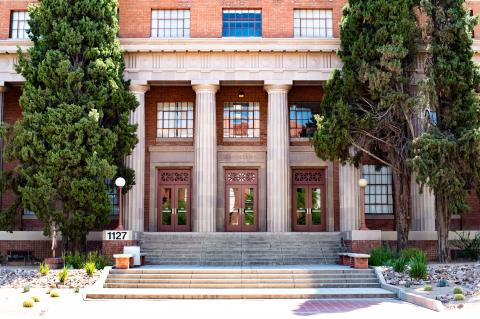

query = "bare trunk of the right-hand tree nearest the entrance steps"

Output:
[[393, 169, 411, 252]]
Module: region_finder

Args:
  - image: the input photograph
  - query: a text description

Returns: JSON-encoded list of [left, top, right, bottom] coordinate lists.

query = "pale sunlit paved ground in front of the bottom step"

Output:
[[0, 288, 480, 319]]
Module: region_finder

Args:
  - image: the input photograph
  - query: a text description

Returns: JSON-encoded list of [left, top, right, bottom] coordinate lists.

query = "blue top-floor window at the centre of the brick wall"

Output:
[[222, 10, 262, 37]]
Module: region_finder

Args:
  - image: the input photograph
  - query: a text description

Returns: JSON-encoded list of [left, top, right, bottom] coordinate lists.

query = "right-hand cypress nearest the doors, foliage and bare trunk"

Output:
[[312, 0, 418, 250]]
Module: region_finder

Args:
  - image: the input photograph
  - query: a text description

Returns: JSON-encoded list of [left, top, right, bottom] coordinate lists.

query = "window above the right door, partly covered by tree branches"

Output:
[[290, 102, 320, 138]]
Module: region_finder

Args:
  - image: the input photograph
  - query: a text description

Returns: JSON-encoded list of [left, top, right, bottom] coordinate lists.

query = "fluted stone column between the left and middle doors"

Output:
[[192, 81, 219, 232]]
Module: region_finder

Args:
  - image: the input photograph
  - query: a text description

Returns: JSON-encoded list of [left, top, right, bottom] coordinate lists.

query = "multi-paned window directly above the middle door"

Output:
[[223, 102, 260, 138]]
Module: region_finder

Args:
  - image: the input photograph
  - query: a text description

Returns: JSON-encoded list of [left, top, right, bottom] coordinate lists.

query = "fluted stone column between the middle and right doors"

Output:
[[265, 82, 292, 232]]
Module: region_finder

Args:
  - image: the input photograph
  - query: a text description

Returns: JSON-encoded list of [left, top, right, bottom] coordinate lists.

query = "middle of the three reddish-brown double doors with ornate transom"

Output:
[[225, 169, 258, 232]]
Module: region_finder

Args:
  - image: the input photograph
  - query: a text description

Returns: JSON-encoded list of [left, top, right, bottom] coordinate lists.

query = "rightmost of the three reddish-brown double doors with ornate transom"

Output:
[[292, 169, 327, 232]]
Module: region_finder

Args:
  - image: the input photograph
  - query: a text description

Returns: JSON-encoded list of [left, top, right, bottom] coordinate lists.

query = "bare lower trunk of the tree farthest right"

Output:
[[435, 194, 450, 263]]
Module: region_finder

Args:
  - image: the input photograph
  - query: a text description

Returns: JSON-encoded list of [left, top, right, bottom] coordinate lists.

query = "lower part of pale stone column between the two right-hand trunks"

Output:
[[411, 175, 435, 231]]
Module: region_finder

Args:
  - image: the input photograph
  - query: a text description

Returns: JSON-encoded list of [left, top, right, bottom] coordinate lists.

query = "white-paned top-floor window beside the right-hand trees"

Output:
[[293, 9, 333, 38]]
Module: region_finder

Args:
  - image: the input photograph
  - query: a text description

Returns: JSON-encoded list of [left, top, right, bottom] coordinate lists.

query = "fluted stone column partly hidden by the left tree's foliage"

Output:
[[124, 84, 150, 232]]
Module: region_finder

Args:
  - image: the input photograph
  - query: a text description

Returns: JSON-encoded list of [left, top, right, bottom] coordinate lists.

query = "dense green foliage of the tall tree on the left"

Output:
[[0, 0, 138, 243]]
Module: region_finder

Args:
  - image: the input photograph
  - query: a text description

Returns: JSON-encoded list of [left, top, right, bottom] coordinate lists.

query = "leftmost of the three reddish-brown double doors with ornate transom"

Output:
[[157, 169, 191, 232]]
